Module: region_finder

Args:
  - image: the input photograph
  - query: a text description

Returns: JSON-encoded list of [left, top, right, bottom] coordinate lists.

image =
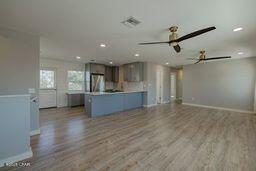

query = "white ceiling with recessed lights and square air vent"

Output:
[[0, 0, 256, 66]]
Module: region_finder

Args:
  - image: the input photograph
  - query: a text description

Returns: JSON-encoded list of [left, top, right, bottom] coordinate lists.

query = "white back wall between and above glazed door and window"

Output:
[[40, 58, 85, 107]]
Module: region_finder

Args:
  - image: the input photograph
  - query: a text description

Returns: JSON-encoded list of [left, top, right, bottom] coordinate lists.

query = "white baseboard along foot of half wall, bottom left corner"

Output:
[[0, 147, 33, 167]]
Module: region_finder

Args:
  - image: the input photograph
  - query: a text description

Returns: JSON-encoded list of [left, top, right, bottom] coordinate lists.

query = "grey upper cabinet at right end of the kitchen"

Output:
[[123, 62, 143, 82]]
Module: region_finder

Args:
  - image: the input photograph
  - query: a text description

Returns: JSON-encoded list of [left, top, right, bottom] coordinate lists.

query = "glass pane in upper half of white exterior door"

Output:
[[40, 69, 55, 89]]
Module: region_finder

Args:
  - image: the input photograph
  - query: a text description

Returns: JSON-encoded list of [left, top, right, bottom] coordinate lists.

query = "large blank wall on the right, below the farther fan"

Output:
[[183, 57, 256, 111]]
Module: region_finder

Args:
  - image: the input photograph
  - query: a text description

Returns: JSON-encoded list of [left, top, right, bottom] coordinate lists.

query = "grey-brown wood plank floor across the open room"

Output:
[[0, 104, 256, 171]]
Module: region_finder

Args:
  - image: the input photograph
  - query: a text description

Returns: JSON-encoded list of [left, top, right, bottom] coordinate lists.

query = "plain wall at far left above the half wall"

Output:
[[0, 28, 40, 95]]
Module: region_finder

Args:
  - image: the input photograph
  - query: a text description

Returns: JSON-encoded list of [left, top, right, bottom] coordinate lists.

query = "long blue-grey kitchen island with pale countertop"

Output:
[[84, 91, 146, 117]]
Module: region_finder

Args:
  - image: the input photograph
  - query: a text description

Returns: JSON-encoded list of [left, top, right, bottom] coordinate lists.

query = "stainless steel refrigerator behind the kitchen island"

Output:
[[91, 74, 105, 92]]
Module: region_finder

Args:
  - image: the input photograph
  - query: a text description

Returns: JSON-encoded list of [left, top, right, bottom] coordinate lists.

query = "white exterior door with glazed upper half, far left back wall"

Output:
[[39, 68, 57, 108]]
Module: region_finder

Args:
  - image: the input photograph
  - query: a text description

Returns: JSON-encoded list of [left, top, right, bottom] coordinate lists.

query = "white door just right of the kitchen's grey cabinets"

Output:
[[156, 71, 163, 104]]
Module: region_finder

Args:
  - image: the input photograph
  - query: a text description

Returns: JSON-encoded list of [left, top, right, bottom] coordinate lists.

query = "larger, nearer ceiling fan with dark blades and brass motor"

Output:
[[139, 26, 216, 53]]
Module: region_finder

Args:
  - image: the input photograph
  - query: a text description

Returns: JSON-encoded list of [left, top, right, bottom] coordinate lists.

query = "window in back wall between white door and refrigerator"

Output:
[[68, 71, 84, 90]]
